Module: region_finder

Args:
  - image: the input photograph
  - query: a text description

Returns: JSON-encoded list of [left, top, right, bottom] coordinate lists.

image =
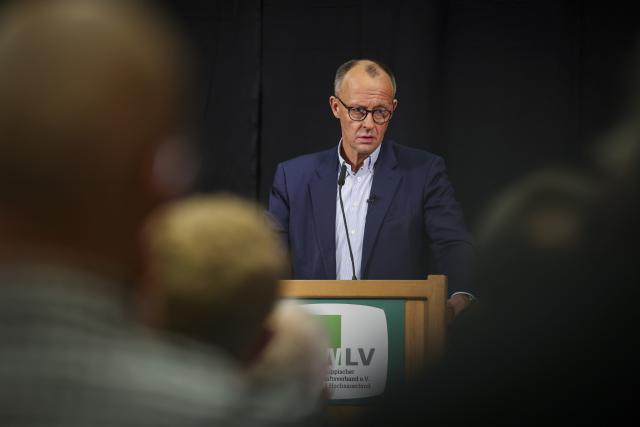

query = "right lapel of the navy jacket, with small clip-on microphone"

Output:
[[361, 141, 401, 279]]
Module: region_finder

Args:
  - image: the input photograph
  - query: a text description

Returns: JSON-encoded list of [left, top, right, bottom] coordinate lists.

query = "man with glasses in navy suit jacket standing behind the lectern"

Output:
[[269, 60, 474, 315]]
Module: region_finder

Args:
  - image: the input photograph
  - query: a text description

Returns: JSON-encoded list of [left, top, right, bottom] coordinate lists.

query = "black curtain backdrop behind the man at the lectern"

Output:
[[164, 0, 640, 230]]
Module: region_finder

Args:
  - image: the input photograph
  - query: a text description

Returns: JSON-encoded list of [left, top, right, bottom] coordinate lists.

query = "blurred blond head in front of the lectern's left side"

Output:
[[145, 195, 286, 361]]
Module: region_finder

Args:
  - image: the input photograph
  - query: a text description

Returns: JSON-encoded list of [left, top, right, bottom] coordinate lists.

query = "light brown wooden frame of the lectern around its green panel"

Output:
[[280, 275, 447, 417]]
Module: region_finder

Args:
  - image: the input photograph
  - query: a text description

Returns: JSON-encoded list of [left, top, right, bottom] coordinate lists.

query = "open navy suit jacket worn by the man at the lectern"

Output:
[[269, 140, 473, 294]]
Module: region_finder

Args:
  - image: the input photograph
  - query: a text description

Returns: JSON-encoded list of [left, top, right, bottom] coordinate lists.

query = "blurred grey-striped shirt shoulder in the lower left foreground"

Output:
[[0, 265, 255, 426]]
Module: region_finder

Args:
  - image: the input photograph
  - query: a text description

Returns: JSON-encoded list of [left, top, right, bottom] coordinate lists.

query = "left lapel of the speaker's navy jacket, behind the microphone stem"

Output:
[[309, 149, 338, 280]]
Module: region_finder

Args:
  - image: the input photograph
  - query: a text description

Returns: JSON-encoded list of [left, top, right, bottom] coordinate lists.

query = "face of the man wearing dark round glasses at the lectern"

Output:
[[329, 66, 398, 165]]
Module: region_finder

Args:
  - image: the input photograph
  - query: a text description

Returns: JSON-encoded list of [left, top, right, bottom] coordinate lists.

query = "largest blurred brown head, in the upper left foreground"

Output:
[[0, 0, 190, 276]]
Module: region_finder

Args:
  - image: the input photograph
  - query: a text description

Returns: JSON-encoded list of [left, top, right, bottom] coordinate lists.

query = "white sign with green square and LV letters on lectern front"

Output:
[[303, 304, 389, 399]]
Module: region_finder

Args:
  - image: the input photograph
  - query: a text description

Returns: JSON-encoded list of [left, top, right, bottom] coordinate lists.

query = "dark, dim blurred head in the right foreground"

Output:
[[478, 169, 598, 308]]
